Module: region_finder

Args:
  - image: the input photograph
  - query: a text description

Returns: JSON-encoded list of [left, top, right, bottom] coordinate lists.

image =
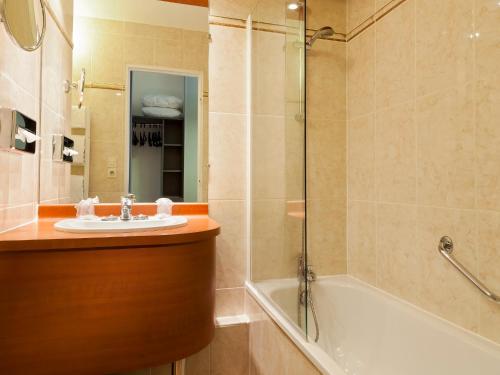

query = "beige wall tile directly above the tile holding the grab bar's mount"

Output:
[[417, 85, 475, 208]]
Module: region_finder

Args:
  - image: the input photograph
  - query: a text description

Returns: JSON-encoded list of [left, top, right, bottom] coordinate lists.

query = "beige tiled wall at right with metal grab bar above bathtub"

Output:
[[347, 0, 500, 342]]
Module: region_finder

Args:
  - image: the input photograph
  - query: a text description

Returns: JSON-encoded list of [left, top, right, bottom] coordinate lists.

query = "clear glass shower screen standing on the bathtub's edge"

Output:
[[251, 1, 309, 333]]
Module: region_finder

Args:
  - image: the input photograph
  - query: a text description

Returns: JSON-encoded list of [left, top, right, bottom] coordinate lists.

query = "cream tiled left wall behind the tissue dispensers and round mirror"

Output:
[[0, 0, 73, 231]]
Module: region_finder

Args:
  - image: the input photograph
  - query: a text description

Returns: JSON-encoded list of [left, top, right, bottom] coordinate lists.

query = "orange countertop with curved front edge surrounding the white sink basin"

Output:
[[0, 205, 220, 253]]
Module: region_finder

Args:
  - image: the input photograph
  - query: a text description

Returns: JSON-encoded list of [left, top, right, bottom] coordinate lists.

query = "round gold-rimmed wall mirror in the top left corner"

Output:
[[0, 0, 46, 51]]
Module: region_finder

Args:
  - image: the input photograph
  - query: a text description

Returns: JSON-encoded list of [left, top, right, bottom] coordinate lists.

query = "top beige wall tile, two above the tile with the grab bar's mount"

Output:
[[416, 0, 474, 96]]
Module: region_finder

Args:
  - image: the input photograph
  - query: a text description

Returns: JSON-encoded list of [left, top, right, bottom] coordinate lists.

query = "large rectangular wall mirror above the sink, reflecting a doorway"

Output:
[[40, 0, 209, 203]]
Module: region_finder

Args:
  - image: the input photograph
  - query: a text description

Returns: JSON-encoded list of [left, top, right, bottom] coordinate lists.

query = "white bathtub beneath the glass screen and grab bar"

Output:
[[248, 275, 500, 375]]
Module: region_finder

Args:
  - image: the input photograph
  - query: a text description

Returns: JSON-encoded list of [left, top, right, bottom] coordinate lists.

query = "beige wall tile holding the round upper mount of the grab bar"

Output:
[[416, 207, 480, 331]]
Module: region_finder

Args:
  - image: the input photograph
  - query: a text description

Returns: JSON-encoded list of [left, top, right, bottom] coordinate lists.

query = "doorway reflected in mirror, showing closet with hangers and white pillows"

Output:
[[125, 67, 203, 202]]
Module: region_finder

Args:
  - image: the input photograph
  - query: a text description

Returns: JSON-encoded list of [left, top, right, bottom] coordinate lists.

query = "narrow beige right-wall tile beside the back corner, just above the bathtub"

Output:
[[347, 202, 377, 285]]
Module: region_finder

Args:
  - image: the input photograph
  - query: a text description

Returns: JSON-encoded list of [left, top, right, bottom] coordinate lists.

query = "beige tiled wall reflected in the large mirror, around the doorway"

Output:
[[73, 17, 208, 202]]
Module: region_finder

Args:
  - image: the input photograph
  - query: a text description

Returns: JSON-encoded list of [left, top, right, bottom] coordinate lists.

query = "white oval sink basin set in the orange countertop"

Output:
[[54, 216, 187, 233]]
